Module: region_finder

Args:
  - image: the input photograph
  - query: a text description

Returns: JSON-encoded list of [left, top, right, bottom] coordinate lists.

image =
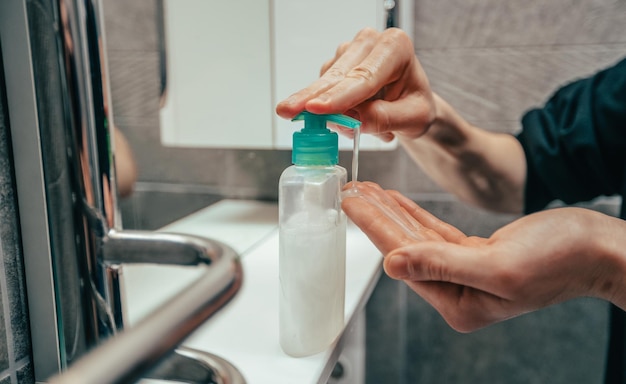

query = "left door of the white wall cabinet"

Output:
[[160, 0, 273, 148]]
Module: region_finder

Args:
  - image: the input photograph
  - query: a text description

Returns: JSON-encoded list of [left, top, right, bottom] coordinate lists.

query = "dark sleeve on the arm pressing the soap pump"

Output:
[[517, 59, 626, 213]]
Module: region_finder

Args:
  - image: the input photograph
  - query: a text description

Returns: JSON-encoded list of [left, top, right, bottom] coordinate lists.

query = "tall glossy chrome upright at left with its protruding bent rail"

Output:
[[0, 0, 242, 384]]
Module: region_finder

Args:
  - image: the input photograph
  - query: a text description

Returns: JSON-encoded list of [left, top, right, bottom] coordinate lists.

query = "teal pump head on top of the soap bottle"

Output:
[[291, 111, 361, 166]]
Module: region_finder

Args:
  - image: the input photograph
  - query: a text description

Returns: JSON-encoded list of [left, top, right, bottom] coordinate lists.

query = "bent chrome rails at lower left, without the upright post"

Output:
[[49, 232, 245, 384]]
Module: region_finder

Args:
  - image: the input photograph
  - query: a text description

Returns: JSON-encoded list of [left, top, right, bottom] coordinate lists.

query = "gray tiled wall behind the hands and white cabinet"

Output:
[[105, 0, 626, 383]]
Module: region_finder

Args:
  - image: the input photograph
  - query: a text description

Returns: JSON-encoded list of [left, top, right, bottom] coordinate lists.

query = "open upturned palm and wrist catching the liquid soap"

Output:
[[342, 183, 626, 332]]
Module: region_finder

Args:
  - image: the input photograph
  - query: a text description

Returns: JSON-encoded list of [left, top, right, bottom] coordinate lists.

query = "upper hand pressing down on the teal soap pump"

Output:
[[276, 28, 435, 141]]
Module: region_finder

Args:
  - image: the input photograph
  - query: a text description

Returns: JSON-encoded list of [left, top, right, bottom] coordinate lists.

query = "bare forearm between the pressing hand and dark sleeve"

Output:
[[399, 95, 526, 213]]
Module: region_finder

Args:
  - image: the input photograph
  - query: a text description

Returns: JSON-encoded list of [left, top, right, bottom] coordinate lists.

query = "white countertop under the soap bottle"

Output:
[[123, 200, 382, 384]]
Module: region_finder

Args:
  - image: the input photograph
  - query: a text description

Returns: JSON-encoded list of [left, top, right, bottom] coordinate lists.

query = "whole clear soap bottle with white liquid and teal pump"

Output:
[[278, 111, 361, 357]]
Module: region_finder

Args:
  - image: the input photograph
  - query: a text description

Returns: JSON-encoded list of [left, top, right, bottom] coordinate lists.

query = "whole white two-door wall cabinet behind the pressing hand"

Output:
[[161, 0, 412, 150]]
